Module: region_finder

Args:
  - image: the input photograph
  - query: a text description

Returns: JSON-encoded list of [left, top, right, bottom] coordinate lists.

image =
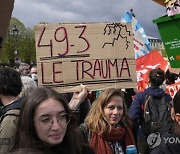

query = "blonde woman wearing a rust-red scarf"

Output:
[[77, 88, 135, 154]]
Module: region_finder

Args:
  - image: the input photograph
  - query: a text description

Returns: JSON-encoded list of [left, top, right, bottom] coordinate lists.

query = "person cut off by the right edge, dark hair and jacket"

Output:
[[151, 90, 180, 154]]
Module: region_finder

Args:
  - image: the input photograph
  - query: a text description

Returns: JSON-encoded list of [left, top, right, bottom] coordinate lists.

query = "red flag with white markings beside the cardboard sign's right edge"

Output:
[[136, 50, 168, 91]]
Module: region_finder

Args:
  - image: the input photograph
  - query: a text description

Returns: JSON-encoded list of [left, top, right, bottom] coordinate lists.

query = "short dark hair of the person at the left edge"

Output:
[[0, 68, 22, 96]]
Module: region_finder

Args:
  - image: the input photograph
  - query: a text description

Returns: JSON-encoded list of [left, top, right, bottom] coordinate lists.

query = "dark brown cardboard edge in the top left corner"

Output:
[[0, 0, 14, 53]]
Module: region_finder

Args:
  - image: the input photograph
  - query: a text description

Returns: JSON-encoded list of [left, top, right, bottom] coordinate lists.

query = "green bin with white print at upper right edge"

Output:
[[153, 14, 180, 68]]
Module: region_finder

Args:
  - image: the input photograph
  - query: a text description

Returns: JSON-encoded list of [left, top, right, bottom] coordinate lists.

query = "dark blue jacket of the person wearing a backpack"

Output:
[[129, 87, 171, 140]]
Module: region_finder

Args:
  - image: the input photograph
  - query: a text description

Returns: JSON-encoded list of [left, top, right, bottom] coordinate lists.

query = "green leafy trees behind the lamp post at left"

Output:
[[0, 17, 36, 66]]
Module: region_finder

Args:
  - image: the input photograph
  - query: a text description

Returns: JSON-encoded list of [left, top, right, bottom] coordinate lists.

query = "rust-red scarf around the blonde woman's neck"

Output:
[[90, 126, 135, 154]]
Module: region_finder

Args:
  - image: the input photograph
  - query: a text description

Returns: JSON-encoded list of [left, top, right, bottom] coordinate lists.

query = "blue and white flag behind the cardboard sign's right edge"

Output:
[[120, 12, 151, 59]]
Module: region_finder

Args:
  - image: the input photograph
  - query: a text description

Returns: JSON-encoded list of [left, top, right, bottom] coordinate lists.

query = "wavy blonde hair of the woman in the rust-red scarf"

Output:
[[85, 88, 131, 135]]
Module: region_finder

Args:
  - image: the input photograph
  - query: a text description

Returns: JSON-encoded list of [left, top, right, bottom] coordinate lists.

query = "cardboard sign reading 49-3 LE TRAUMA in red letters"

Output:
[[35, 23, 136, 92]]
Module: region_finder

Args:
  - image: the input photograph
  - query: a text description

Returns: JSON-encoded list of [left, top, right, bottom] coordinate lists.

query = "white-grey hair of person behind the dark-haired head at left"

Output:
[[20, 76, 37, 97]]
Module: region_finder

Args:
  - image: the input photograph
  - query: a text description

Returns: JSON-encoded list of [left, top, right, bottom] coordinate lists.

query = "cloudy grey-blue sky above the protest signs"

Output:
[[12, 0, 166, 37]]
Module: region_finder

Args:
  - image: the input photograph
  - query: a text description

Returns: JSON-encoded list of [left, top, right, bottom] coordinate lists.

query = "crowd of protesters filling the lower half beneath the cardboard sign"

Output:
[[0, 63, 180, 154]]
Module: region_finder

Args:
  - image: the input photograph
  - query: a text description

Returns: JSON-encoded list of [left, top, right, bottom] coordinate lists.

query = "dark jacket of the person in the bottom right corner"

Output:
[[150, 131, 180, 154]]
